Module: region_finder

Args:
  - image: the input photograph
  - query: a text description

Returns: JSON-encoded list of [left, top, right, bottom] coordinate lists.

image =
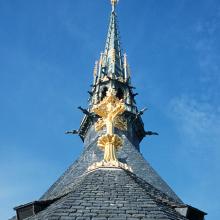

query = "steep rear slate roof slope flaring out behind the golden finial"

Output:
[[41, 128, 182, 203]]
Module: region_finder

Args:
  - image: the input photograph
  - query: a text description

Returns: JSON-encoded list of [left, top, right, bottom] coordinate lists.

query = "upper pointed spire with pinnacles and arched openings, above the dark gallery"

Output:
[[89, 0, 137, 114]]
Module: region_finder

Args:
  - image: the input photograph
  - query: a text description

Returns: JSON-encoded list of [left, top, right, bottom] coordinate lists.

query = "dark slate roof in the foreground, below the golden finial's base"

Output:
[[27, 169, 186, 220]]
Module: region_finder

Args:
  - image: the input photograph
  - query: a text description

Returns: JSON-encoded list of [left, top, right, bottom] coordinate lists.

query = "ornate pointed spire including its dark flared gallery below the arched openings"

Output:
[[79, 0, 145, 141]]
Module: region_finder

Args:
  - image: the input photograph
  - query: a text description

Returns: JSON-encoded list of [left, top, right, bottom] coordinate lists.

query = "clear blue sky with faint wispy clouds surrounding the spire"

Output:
[[0, 0, 220, 220]]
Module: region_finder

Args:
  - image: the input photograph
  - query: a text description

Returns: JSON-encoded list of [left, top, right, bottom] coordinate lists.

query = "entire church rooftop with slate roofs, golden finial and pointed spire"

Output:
[[11, 0, 206, 220]]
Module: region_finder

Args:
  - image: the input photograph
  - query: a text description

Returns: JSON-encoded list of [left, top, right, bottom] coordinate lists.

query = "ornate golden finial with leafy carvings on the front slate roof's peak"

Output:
[[89, 88, 132, 171]]
